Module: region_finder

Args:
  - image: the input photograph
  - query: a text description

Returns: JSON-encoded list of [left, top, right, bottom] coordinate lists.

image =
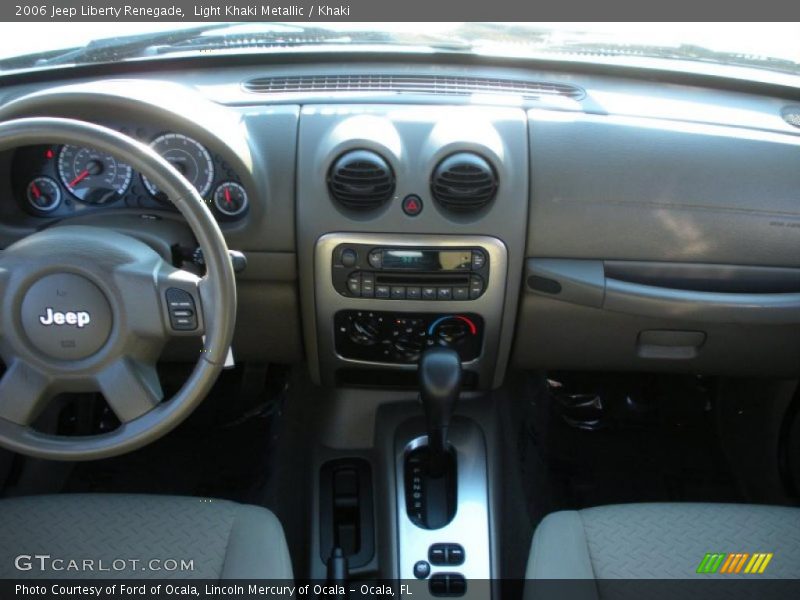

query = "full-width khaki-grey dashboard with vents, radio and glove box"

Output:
[[0, 57, 800, 389]]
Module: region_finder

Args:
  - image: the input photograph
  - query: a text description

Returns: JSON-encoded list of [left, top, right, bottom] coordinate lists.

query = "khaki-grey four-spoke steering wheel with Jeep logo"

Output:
[[0, 118, 236, 460]]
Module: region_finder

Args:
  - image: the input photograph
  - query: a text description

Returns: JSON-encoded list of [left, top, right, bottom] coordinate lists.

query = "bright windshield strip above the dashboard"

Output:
[[0, 22, 800, 82]]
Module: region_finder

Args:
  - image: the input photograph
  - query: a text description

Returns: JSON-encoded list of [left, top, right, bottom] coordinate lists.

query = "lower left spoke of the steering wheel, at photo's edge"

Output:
[[0, 359, 51, 425]]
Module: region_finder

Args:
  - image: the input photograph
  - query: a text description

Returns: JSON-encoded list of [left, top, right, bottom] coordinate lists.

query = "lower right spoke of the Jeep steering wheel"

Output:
[[97, 358, 164, 423]]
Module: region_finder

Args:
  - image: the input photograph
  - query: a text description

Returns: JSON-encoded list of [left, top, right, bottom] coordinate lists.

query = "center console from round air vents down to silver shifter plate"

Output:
[[296, 104, 530, 598]]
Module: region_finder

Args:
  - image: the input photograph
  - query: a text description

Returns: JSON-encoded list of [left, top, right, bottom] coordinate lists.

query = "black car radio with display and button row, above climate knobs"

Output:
[[331, 244, 490, 301]]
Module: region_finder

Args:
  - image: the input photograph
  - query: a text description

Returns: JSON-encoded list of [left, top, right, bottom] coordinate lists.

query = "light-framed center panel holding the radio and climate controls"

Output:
[[314, 233, 507, 388]]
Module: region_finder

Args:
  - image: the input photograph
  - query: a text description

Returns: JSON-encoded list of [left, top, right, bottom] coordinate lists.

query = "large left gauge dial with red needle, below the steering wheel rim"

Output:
[[58, 145, 133, 204]]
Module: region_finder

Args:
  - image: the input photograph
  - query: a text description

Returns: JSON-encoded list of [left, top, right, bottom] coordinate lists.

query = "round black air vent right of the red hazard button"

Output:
[[431, 152, 497, 213]]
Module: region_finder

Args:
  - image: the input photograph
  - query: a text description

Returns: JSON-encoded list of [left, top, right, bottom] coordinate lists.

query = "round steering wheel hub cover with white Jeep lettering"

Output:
[[21, 273, 112, 360]]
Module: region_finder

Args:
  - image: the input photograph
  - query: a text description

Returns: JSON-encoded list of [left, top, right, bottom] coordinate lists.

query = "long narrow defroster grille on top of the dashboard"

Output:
[[242, 74, 585, 100]]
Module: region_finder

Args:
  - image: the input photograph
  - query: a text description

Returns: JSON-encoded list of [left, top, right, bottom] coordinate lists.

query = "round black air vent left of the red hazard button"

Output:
[[328, 150, 395, 211]]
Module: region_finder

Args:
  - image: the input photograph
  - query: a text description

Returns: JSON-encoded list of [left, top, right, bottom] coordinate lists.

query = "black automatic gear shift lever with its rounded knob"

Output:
[[419, 347, 461, 474]]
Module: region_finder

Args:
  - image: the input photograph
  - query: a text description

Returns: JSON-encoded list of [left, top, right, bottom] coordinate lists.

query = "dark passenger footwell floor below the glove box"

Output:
[[521, 373, 742, 523]]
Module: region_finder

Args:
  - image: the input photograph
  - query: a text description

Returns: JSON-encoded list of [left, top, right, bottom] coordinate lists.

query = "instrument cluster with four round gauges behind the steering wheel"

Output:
[[12, 127, 249, 220]]
